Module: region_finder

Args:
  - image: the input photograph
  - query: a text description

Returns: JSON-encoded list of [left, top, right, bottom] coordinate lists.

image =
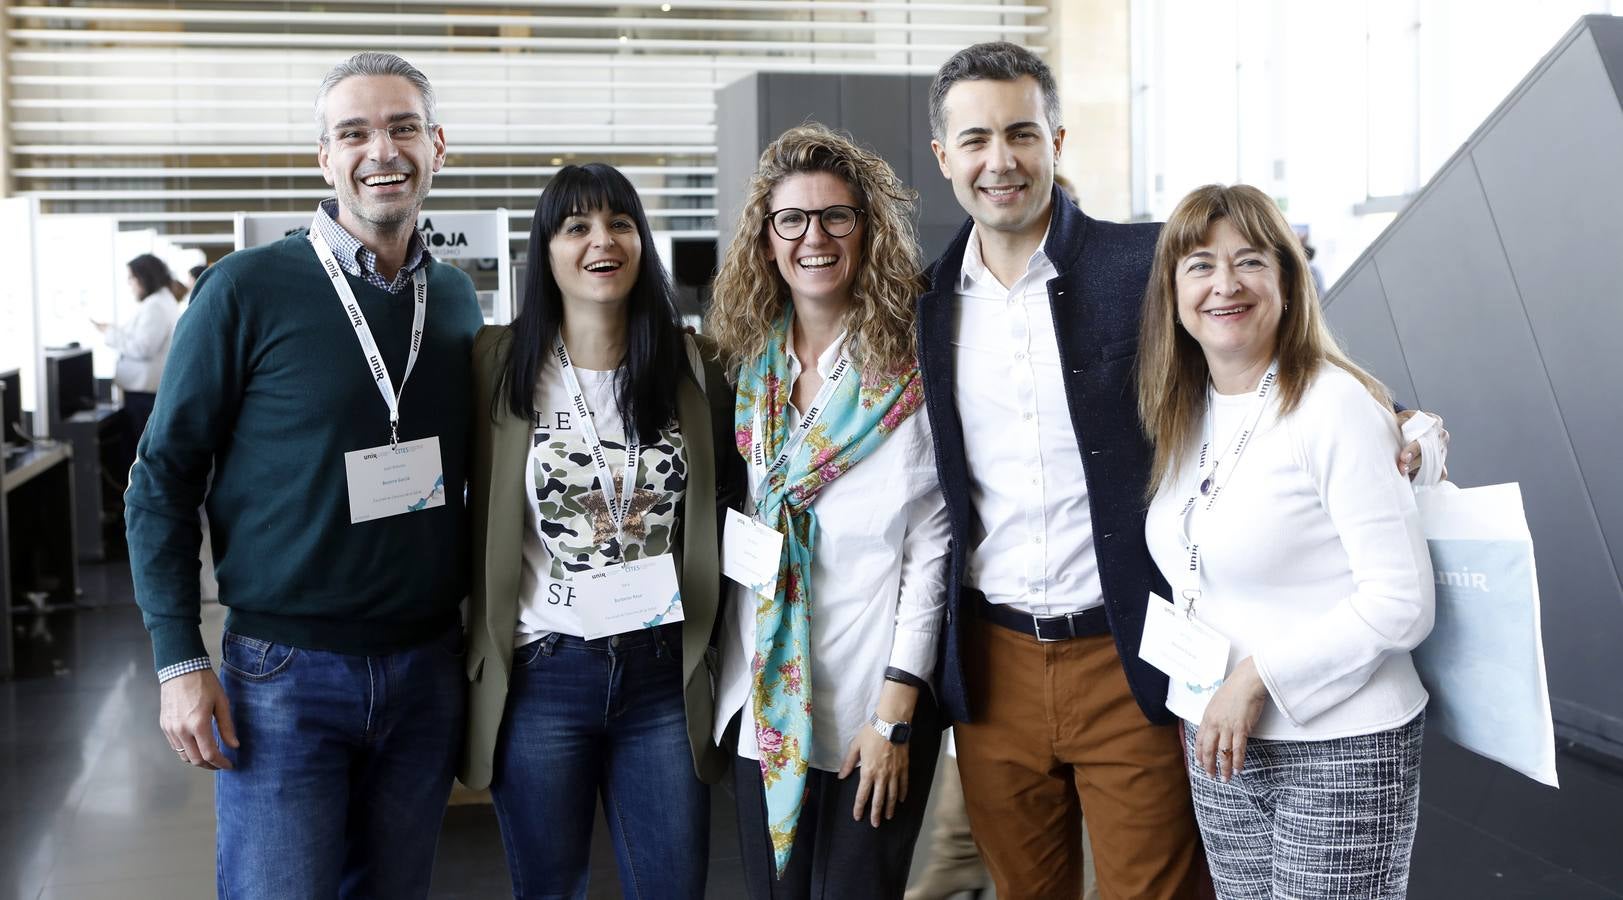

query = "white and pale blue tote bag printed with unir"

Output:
[[1414, 482, 1558, 786]]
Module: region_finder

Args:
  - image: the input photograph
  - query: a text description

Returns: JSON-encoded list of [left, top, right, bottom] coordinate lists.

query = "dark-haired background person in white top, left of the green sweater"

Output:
[[94, 253, 180, 447]]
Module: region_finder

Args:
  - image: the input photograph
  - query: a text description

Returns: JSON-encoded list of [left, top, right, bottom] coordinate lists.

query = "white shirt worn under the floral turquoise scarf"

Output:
[[714, 334, 948, 772]]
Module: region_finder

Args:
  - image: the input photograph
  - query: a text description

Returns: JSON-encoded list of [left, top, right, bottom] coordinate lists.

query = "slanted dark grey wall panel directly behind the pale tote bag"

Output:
[[1375, 159, 1623, 745]]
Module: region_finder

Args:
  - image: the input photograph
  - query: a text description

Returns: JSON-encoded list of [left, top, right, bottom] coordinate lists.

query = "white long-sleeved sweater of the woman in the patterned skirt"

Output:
[[1144, 363, 1433, 739]]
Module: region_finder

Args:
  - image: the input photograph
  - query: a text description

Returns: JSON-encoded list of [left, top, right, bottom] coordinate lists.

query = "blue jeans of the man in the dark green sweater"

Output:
[[214, 631, 466, 900]]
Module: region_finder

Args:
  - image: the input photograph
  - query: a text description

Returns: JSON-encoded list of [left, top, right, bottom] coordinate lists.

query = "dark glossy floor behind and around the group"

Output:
[[0, 564, 1623, 900]]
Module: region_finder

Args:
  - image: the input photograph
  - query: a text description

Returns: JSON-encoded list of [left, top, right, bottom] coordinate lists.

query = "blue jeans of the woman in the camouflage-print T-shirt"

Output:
[[490, 624, 709, 900]]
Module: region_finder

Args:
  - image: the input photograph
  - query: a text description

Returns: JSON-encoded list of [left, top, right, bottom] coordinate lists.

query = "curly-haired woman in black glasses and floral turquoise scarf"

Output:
[[709, 125, 948, 898]]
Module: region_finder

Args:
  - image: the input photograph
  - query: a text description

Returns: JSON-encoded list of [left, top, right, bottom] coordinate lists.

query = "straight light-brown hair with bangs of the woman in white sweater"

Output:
[[1138, 185, 1391, 496]]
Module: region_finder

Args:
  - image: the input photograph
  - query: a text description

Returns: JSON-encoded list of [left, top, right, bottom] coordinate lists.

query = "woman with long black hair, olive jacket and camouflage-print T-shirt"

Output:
[[461, 164, 740, 897]]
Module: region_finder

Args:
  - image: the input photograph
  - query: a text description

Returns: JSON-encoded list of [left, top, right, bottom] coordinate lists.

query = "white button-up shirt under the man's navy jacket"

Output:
[[953, 225, 1104, 616]]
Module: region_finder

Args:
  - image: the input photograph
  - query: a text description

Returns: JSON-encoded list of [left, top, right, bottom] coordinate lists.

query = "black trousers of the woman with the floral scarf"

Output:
[[730, 691, 941, 900]]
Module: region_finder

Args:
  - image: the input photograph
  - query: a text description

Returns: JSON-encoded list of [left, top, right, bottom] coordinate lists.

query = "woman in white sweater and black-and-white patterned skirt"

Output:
[[1138, 185, 1433, 898]]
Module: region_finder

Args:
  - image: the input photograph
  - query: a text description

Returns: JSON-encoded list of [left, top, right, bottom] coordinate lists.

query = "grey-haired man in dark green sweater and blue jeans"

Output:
[[125, 54, 480, 898]]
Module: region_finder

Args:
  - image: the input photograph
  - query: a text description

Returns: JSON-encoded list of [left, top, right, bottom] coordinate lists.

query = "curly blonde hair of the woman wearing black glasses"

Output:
[[706, 122, 923, 371]]
